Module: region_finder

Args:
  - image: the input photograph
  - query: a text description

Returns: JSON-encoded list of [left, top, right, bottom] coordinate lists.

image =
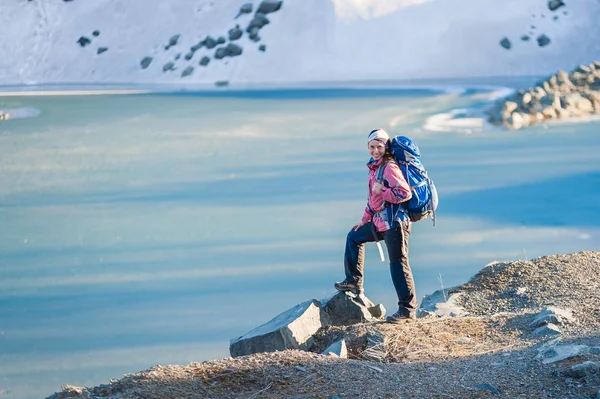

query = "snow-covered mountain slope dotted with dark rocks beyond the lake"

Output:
[[0, 0, 600, 85]]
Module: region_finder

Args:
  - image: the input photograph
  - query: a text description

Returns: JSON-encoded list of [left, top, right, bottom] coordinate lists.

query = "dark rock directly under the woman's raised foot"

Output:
[[321, 292, 376, 326]]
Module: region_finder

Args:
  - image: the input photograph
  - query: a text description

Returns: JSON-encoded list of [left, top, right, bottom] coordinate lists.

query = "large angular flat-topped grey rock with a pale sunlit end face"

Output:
[[231, 300, 330, 357]]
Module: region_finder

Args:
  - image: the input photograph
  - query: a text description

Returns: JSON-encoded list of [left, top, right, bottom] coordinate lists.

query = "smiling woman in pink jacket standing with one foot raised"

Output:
[[334, 129, 417, 323]]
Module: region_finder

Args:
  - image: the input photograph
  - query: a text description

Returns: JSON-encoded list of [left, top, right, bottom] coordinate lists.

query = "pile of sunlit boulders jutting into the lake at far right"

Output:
[[488, 61, 600, 129]]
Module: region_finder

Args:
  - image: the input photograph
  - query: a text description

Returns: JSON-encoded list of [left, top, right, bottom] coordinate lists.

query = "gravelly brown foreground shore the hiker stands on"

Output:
[[50, 252, 600, 399]]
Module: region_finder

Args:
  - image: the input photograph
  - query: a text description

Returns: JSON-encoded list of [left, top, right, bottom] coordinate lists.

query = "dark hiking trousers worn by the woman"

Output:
[[344, 221, 417, 315]]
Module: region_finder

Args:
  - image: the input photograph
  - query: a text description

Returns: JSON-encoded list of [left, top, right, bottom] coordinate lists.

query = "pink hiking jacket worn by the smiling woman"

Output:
[[362, 158, 412, 232]]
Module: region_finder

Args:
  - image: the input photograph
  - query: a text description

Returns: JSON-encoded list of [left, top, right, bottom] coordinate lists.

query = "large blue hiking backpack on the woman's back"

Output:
[[377, 136, 438, 226]]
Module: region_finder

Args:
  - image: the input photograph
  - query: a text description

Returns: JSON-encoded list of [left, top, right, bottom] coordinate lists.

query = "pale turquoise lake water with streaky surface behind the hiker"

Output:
[[0, 85, 600, 398]]
